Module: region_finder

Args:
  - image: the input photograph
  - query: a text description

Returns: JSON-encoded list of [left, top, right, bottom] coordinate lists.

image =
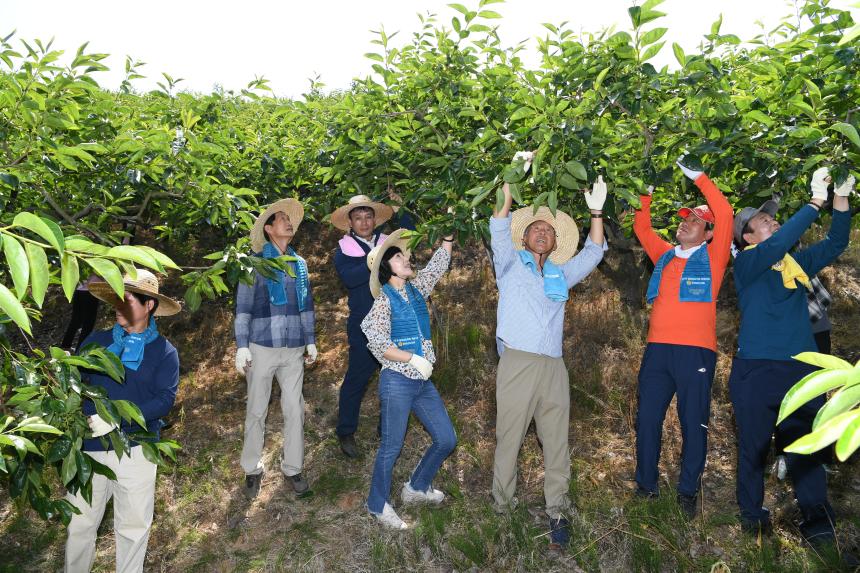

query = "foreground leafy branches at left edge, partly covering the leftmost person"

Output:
[[0, 212, 178, 523]]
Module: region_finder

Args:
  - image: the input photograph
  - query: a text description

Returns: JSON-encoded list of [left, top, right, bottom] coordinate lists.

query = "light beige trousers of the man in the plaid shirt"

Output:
[[241, 344, 305, 476]]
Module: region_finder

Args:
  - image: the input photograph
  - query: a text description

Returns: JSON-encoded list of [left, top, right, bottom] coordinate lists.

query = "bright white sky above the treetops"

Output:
[[0, 0, 860, 97]]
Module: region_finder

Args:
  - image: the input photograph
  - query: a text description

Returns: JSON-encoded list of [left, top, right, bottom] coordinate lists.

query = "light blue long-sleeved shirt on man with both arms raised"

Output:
[[490, 215, 609, 358]]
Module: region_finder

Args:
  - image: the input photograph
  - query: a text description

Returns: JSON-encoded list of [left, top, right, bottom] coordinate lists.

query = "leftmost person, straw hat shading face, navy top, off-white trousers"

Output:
[[65, 269, 180, 573]]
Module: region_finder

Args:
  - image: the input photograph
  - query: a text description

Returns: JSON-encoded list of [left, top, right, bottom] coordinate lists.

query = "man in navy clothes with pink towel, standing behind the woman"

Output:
[[331, 189, 415, 459]]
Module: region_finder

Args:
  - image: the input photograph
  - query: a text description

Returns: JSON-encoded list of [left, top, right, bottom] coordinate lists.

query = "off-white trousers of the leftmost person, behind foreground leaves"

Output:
[[65, 446, 156, 573]]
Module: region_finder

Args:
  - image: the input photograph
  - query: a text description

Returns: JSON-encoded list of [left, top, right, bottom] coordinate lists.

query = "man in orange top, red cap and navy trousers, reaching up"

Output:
[[633, 161, 733, 519]]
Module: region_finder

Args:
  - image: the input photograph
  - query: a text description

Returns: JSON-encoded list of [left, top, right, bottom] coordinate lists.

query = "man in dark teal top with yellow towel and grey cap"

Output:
[[729, 168, 854, 545]]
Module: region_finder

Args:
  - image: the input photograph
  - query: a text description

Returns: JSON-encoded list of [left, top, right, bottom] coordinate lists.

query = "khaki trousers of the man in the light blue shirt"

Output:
[[493, 348, 570, 518]]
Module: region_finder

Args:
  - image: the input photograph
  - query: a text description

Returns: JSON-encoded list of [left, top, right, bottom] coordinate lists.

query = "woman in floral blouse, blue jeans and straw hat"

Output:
[[361, 229, 457, 529]]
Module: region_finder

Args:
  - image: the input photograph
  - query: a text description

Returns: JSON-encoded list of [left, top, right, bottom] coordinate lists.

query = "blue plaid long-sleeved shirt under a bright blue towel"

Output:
[[234, 262, 316, 348]]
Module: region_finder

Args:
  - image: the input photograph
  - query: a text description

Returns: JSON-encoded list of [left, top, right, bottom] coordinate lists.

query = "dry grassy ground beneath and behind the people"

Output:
[[0, 223, 860, 572]]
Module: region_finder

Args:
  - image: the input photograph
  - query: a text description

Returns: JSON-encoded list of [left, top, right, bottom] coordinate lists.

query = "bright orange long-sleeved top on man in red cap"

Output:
[[633, 174, 734, 352]]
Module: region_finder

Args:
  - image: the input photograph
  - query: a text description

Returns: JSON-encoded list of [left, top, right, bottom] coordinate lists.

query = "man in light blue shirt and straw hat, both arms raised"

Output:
[[490, 154, 607, 547]]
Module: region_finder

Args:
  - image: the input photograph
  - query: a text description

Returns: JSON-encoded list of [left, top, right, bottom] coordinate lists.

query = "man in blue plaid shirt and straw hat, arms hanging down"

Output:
[[234, 199, 317, 499]]
